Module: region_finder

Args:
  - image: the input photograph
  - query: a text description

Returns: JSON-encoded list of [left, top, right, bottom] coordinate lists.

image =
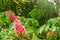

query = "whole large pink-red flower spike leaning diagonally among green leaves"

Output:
[[6, 11, 27, 35]]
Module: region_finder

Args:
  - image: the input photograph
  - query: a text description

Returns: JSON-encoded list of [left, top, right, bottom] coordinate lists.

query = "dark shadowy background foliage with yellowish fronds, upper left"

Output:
[[0, 0, 37, 17]]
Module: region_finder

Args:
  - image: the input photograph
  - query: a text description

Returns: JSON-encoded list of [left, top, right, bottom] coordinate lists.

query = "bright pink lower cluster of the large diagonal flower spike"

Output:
[[14, 21, 26, 35]]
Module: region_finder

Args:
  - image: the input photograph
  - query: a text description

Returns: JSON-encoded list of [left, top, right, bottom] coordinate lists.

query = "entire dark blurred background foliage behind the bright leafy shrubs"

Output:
[[0, 0, 58, 25]]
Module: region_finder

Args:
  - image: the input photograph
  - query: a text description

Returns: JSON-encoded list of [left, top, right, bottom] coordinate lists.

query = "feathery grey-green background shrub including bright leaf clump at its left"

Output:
[[29, 0, 58, 25]]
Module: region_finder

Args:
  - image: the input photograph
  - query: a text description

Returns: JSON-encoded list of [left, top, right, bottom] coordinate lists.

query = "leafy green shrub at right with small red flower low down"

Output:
[[37, 17, 60, 40]]
